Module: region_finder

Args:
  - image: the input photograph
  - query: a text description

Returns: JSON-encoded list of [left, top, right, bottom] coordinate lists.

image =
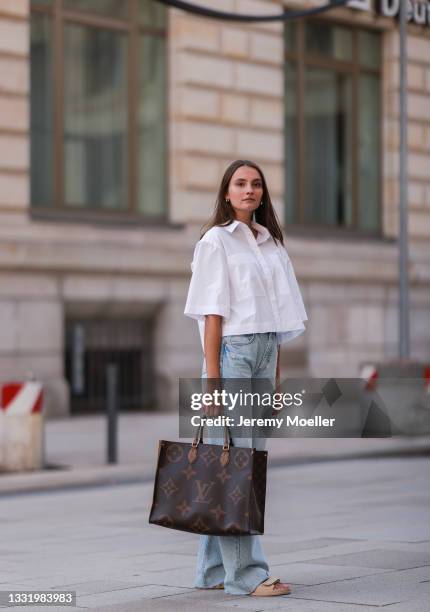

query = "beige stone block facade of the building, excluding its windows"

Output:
[[0, 0, 430, 415]]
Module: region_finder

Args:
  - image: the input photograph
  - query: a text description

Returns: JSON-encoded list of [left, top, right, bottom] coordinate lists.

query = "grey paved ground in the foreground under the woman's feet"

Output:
[[0, 457, 430, 612]]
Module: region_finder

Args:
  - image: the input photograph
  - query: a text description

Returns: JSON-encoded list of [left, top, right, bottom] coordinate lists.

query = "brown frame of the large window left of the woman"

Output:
[[30, 0, 170, 225]]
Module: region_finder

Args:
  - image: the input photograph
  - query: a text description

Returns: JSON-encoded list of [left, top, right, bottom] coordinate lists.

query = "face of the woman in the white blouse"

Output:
[[225, 166, 263, 215]]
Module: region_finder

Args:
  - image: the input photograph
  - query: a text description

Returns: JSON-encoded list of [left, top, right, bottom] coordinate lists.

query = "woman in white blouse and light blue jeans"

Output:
[[185, 160, 307, 597]]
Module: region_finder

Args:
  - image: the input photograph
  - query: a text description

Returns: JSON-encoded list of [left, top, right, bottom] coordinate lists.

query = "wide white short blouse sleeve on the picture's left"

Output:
[[184, 240, 230, 321]]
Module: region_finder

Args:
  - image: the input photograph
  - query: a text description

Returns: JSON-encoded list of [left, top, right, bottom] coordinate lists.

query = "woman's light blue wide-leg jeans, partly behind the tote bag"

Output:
[[194, 332, 278, 595]]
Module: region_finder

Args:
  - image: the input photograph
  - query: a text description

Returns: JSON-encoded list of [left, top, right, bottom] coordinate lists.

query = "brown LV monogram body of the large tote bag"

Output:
[[149, 440, 267, 535]]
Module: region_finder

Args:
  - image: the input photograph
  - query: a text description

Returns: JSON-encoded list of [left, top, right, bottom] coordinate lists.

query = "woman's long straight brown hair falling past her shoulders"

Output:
[[200, 159, 284, 244]]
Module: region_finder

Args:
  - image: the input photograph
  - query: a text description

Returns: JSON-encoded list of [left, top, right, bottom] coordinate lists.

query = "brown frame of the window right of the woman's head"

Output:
[[283, 18, 384, 240]]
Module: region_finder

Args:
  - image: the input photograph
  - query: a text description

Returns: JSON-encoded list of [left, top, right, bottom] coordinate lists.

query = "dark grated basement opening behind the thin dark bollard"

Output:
[[65, 318, 155, 413]]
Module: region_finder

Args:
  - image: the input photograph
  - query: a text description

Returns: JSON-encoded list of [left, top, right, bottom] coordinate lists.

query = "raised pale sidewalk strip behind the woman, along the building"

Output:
[[0, 413, 430, 494]]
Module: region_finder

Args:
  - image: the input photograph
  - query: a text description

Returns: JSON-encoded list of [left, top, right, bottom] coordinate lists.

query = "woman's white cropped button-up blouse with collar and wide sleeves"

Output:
[[184, 220, 308, 347]]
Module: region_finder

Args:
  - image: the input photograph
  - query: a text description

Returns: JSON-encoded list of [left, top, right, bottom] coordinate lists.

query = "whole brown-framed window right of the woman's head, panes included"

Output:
[[285, 20, 381, 234]]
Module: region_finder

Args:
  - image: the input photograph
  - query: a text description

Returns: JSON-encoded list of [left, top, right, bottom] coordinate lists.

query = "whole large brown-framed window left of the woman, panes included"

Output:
[[31, 0, 167, 220]]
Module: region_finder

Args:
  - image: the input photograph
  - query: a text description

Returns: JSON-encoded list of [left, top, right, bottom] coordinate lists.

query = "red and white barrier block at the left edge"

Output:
[[0, 381, 44, 472]]
